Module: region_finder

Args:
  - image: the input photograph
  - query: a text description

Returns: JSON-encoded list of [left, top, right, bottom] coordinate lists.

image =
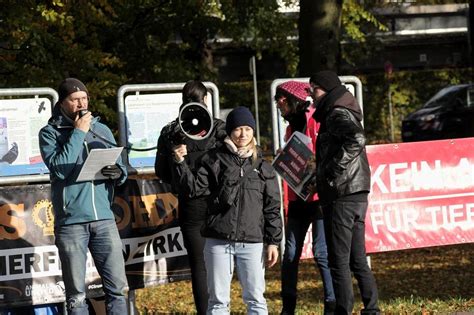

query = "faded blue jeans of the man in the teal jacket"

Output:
[[54, 220, 128, 315]]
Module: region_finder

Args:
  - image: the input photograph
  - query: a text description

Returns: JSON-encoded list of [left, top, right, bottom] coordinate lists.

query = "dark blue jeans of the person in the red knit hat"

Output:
[[281, 215, 336, 310]]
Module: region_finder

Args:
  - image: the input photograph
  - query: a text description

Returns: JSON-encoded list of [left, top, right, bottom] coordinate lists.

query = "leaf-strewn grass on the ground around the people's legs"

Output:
[[136, 244, 474, 314]]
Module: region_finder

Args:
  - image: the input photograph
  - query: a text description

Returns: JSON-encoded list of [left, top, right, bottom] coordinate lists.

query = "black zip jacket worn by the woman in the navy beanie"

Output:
[[176, 146, 282, 245]]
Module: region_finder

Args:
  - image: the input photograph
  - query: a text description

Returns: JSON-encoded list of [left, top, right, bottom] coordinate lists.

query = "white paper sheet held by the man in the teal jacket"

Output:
[[76, 147, 123, 182]]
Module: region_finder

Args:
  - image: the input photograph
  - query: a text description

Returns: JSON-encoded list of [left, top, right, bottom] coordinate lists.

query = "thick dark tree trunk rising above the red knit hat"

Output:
[[298, 0, 343, 76]]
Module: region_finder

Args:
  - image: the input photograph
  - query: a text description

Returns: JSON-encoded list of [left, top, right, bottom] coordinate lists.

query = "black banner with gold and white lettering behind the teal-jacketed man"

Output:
[[0, 179, 190, 308]]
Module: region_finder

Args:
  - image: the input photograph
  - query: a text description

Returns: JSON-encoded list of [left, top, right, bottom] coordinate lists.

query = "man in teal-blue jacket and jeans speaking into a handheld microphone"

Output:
[[39, 78, 127, 315]]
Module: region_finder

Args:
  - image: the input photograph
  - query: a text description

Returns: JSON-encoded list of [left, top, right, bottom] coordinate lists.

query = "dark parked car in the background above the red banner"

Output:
[[402, 84, 474, 142]]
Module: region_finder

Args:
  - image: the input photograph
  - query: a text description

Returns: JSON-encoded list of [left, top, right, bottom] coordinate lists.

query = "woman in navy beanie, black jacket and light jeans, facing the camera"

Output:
[[174, 107, 282, 314]]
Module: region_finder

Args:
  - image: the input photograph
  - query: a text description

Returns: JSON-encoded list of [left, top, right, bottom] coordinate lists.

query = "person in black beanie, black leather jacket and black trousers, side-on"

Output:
[[309, 71, 380, 314]]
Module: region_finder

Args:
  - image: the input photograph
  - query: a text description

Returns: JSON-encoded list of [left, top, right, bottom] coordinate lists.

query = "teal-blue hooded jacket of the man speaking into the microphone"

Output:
[[39, 105, 127, 226]]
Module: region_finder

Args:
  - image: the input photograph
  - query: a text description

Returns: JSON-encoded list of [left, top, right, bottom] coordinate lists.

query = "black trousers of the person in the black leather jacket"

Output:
[[322, 194, 380, 314]]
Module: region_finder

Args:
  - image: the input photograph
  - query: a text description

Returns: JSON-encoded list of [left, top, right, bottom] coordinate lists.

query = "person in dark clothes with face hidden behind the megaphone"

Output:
[[155, 80, 227, 314]]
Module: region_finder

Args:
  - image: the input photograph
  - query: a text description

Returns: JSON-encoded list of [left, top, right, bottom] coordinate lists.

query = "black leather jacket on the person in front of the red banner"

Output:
[[314, 86, 370, 202]]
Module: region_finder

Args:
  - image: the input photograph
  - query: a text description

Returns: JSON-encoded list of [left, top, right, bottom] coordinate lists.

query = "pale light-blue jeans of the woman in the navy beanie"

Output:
[[204, 238, 268, 314]]
